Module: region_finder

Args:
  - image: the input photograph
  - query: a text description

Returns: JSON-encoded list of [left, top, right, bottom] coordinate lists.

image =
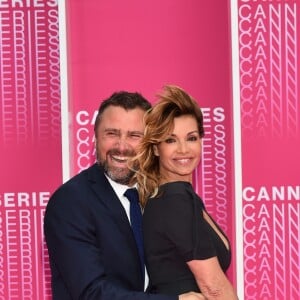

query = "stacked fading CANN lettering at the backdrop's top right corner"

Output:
[[239, 0, 299, 137]]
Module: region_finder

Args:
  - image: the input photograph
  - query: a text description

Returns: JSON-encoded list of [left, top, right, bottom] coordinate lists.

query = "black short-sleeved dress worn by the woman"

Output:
[[143, 181, 231, 295]]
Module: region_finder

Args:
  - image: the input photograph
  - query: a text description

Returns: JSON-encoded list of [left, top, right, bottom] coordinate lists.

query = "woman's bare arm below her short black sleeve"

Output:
[[187, 257, 238, 300]]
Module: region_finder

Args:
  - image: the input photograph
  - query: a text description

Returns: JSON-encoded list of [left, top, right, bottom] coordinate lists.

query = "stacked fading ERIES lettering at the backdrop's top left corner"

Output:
[[0, 0, 60, 143]]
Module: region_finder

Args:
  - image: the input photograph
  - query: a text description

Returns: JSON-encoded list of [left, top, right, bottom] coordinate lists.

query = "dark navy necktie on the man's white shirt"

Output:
[[124, 188, 145, 278]]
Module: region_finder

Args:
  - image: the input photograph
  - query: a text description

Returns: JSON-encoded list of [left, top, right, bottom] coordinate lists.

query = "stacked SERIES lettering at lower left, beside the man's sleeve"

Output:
[[0, 192, 50, 299]]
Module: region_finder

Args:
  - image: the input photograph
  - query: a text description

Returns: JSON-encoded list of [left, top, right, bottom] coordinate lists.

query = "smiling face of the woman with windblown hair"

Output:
[[155, 115, 202, 183]]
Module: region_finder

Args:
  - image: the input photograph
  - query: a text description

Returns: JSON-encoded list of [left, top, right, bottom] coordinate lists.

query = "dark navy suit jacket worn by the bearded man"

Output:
[[44, 164, 178, 300]]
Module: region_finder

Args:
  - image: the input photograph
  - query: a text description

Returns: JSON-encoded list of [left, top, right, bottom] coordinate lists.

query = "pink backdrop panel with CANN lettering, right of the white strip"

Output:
[[239, 1, 300, 300]]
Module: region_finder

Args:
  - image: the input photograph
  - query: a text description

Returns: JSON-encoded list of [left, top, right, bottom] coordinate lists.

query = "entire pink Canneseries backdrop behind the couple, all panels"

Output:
[[0, 0, 300, 300]]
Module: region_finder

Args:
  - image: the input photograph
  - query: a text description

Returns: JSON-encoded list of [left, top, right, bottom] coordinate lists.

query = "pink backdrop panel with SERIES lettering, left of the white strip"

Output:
[[0, 0, 62, 300]]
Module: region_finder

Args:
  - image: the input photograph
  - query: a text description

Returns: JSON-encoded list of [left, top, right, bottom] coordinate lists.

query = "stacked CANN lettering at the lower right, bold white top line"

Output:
[[243, 185, 300, 299]]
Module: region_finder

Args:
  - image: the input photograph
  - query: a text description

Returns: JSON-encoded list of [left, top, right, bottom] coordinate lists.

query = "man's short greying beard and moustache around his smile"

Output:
[[97, 149, 135, 185]]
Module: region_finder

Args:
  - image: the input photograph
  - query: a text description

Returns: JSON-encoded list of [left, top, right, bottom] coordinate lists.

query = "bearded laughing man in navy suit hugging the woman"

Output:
[[44, 92, 203, 300]]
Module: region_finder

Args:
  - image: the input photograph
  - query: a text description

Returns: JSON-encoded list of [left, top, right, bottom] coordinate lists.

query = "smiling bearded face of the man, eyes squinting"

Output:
[[96, 106, 145, 184]]
